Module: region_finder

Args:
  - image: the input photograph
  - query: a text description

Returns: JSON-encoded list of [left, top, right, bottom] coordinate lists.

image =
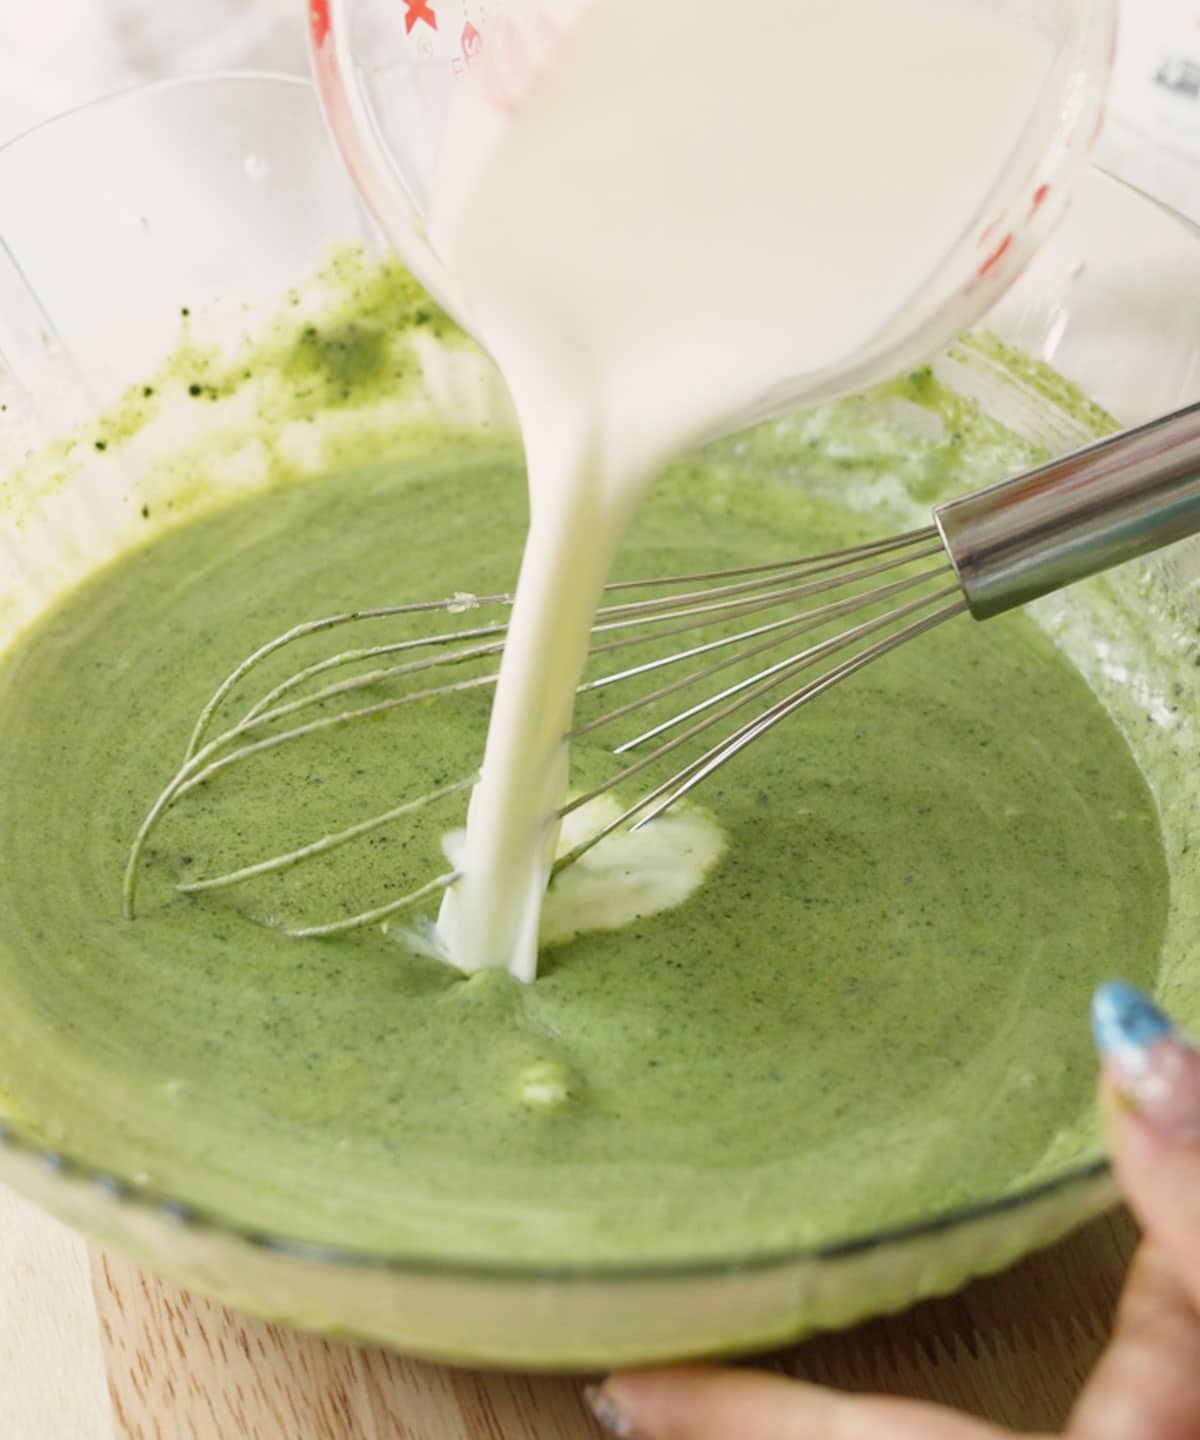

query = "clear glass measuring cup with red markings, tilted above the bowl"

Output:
[[310, 0, 1115, 417]]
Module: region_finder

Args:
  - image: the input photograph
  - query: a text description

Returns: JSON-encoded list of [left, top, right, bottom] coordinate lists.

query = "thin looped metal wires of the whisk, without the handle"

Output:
[[122, 527, 962, 937]]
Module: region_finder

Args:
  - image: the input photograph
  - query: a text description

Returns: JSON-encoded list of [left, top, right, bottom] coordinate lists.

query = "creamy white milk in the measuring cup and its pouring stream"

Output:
[[429, 0, 1050, 979]]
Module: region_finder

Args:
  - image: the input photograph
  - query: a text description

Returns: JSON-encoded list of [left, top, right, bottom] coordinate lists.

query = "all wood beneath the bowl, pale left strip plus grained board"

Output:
[[0, 1191, 1135, 1440]]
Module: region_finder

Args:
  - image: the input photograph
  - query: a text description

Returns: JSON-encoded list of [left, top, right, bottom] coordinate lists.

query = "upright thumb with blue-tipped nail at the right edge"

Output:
[[1092, 984, 1200, 1312]]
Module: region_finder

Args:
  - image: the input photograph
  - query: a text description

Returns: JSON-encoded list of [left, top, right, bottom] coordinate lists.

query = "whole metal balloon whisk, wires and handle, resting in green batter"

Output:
[[124, 403, 1200, 937]]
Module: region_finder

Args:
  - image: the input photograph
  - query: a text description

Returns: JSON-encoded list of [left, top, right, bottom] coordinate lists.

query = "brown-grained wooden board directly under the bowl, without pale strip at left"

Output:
[[92, 1214, 1135, 1440]]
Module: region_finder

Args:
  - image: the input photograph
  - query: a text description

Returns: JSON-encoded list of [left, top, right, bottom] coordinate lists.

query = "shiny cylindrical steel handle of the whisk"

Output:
[[933, 403, 1200, 621]]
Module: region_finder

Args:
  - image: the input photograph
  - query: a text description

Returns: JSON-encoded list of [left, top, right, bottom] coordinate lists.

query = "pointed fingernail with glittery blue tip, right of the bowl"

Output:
[[1092, 981, 1200, 1140]]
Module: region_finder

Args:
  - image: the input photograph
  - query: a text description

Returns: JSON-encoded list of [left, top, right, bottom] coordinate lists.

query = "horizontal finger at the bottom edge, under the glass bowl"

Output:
[[588, 1368, 1011, 1440]]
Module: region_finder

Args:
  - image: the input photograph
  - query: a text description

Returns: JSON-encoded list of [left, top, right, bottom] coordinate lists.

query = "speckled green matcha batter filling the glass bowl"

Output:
[[0, 420, 1167, 1264]]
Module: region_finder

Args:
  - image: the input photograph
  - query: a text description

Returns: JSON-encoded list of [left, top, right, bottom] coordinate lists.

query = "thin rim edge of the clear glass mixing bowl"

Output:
[[0, 68, 1123, 1284]]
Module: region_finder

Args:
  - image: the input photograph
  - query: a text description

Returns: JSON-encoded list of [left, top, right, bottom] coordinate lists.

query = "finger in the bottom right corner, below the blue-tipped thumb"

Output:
[[1067, 1241, 1200, 1440]]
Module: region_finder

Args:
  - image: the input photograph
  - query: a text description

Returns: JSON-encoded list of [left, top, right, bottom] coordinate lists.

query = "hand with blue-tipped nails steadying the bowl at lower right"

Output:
[[589, 985, 1200, 1440]]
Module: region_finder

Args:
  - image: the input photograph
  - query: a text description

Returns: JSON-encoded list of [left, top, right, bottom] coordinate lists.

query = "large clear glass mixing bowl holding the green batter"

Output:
[[0, 75, 1200, 1368]]
